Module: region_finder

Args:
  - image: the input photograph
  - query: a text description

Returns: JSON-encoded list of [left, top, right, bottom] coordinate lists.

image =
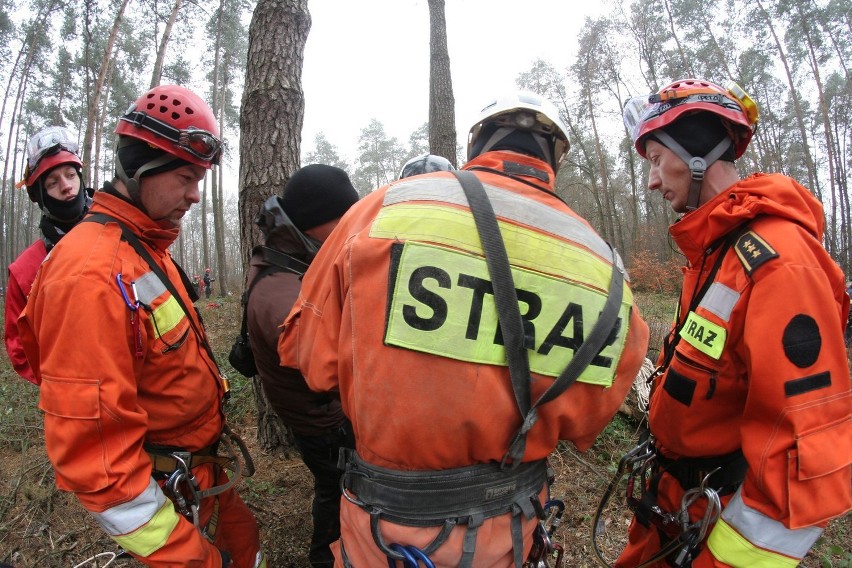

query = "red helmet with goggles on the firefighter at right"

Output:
[[624, 79, 758, 158]]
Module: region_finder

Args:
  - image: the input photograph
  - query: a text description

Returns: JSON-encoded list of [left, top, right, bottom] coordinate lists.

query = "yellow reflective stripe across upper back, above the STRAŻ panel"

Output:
[[370, 203, 616, 290]]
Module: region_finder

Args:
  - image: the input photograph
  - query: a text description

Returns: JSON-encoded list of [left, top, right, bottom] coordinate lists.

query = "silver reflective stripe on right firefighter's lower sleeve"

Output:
[[722, 487, 822, 558]]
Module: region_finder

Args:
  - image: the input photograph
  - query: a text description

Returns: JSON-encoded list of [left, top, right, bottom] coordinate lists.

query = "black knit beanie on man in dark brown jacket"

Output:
[[281, 164, 358, 232]]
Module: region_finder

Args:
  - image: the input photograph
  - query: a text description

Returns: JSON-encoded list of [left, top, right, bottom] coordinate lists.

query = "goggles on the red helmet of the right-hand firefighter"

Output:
[[622, 83, 758, 143]]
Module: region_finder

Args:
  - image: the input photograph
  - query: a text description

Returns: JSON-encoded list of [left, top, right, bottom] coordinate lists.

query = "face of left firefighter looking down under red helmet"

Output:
[[139, 164, 207, 228]]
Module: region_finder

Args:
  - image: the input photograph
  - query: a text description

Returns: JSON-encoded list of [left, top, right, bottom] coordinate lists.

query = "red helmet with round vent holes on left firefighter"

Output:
[[115, 85, 222, 169]]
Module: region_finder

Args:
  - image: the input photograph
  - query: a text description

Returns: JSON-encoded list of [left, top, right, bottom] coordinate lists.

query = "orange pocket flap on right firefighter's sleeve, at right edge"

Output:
[[796, 418, 852, 480]]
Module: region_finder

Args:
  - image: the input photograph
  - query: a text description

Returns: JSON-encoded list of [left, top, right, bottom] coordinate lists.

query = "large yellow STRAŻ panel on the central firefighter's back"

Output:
[[385, 242, 632, 387]]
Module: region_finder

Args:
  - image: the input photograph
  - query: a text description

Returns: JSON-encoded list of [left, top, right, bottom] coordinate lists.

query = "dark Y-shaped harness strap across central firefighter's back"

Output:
[[453, 170, 624, 467]]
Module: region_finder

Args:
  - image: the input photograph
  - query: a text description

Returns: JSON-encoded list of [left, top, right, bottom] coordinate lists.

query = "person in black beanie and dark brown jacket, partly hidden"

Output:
[[247, 164, 358, 568]]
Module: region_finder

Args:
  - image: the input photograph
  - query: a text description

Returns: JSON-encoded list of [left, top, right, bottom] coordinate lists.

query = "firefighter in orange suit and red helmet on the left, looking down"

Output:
[[19, 85, 265, 568]]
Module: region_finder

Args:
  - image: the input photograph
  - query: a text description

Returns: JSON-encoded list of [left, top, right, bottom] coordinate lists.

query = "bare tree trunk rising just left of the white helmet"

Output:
[[429, 0, 458, 165]]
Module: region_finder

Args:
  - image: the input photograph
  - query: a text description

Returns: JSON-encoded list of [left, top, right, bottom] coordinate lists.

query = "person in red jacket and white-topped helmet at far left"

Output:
[[5, 126, 94, 385]]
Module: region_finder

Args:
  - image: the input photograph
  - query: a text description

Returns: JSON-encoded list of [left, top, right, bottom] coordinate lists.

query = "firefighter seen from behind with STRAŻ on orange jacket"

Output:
[[279, 92, 648, 568]]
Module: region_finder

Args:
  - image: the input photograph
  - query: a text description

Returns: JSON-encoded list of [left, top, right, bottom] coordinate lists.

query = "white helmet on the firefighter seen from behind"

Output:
[[467, 91, 570, 169]]
